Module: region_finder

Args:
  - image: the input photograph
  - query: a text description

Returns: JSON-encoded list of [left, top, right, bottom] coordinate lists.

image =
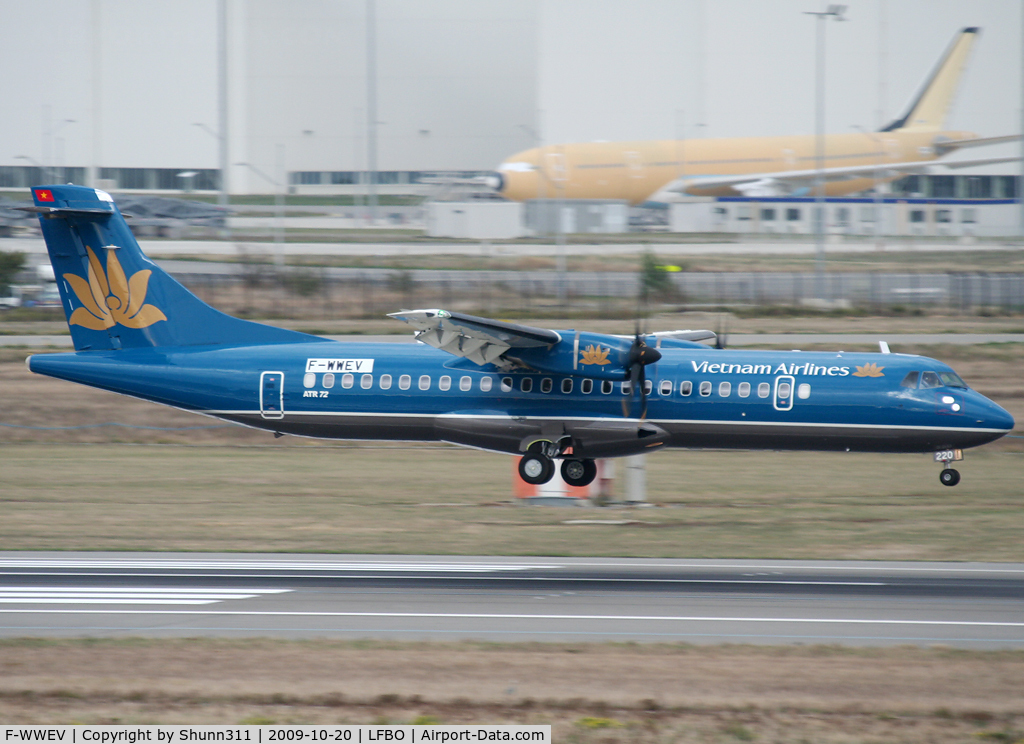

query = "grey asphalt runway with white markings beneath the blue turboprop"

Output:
[[0, 553, 1024, 648]]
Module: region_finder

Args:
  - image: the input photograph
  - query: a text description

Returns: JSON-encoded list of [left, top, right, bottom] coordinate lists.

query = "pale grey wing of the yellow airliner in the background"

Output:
[[651, 158, 1020, 202]]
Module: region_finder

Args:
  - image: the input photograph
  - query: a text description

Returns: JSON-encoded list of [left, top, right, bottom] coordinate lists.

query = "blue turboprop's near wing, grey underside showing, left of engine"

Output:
[[388, 310, 562, 364]]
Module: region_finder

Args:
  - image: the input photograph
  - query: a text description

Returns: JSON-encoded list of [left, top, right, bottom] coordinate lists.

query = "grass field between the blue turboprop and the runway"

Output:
[[0, 443, 1024, 561]]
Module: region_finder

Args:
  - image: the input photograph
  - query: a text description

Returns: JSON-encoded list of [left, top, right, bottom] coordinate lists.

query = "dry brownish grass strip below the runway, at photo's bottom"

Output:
[[0, 639, 1024, 744]]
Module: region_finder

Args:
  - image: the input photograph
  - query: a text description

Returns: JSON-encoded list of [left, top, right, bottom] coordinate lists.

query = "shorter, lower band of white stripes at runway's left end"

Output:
[[0, 586, 291, 605]]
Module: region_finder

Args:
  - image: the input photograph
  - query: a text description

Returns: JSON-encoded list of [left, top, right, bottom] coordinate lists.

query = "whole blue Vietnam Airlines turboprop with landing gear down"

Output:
[[25, 185, 1014, 486]]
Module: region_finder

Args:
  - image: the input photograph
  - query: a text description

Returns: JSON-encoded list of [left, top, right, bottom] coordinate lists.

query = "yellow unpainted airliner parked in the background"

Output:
[[491, 28, 1019, 204]]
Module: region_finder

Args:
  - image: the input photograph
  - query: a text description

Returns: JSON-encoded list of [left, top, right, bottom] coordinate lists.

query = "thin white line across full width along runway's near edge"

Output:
[[0, 609, 1024, 627]]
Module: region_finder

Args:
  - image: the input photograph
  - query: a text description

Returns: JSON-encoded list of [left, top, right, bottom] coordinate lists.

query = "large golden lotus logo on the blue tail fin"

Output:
[[63, 247, 167, 331]]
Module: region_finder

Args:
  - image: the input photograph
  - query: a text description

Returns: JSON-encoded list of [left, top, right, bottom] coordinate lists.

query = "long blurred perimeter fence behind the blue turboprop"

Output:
[[178, 265, 1024, 318]]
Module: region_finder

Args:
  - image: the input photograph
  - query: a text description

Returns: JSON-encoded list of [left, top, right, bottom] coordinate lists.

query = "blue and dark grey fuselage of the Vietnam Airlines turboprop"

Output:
[[29, 341, 1014, 457]]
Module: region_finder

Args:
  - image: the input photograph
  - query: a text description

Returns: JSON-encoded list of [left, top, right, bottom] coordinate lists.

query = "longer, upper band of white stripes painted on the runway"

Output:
[[0, 558, 561, 573]]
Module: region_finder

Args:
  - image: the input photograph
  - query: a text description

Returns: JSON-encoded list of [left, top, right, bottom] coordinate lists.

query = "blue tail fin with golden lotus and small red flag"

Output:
[[26, 184, 315, 351]]
